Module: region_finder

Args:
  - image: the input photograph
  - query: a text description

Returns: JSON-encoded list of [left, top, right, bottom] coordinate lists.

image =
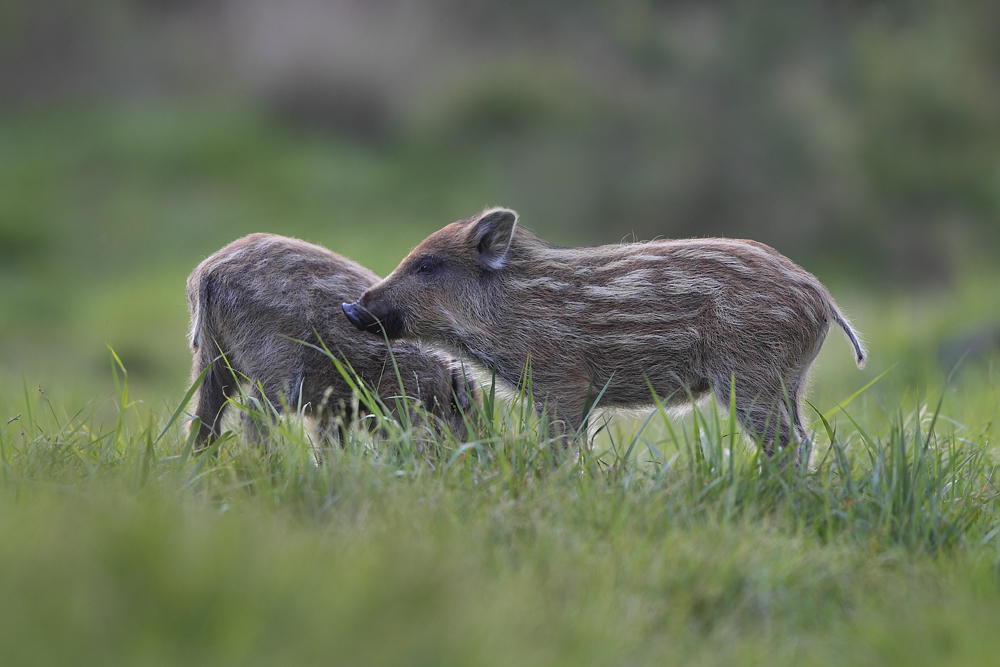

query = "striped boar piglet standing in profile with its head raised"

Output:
[[343, 209, 866, 453]]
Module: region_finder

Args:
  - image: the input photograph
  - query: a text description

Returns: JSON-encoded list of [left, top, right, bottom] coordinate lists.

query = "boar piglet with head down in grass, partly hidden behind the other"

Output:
[[187, 234, 479, 445]]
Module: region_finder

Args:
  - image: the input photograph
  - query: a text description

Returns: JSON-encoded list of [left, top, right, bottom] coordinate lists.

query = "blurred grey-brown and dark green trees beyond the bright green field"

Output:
[[0, 0, 1000, 284]]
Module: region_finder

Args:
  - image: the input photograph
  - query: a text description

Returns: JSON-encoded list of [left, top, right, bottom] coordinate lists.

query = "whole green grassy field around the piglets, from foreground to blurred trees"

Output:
[[0, 104, 1000, 665]]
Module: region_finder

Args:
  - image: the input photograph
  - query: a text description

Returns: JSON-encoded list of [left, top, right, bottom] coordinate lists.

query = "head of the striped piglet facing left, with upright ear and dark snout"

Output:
[[343, 208, 517, 342]]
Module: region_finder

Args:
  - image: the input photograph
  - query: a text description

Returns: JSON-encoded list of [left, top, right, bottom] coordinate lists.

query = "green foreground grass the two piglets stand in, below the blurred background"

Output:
[[0, 352, 1000, 665]]
